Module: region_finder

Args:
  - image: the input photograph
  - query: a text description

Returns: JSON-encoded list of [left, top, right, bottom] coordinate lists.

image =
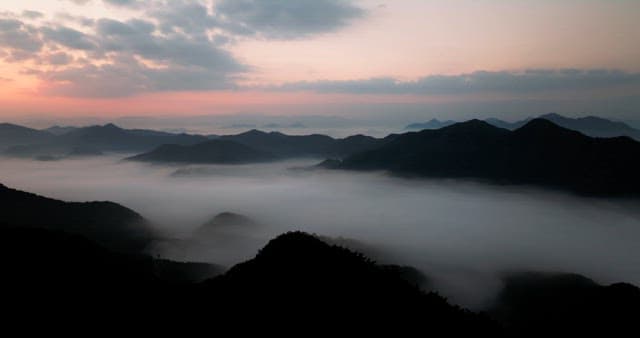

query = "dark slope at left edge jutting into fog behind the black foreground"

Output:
[[0, 184, 153, 251]]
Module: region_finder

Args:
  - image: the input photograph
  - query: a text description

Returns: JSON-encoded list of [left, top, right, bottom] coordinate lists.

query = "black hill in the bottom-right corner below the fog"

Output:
[[490, 272, 640, 337]]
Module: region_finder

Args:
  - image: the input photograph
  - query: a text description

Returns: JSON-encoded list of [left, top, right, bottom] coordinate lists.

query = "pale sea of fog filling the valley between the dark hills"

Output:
[[0, 155, 640, 308]]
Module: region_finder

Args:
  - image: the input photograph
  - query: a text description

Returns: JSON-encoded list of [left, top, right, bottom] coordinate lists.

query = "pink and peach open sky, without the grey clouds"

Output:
[[0, 0, 640, 118]]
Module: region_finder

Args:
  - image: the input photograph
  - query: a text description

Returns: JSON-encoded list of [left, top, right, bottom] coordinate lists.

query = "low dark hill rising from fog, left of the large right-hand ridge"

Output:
[[127, 139, 278, 164]]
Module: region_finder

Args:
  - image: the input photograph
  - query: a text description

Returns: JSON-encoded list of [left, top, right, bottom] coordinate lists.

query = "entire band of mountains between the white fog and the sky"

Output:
[[0, 114, 640, 195]]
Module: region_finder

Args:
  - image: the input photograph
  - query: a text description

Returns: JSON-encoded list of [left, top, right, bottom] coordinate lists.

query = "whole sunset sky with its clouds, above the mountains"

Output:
[[0, 0, 640, 122]]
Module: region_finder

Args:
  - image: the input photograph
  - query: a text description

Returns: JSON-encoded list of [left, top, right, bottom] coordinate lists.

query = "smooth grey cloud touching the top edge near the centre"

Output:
[[215, 0, 365, 39]]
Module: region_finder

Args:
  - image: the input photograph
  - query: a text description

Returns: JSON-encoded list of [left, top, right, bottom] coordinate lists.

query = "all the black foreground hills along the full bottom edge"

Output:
[[5, 222, 640, 337]]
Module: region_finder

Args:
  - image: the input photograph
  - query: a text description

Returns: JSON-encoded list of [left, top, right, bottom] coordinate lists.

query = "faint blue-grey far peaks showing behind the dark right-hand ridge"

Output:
[[405, 113, 640, 141]]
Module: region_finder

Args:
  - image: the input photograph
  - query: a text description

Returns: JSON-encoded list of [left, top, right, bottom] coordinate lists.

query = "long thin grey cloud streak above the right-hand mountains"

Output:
[[276, 69, 640, 95]]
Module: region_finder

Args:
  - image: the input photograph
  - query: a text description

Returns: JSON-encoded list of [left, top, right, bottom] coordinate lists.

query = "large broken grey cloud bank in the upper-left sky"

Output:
[[0, 0, 363, 97]]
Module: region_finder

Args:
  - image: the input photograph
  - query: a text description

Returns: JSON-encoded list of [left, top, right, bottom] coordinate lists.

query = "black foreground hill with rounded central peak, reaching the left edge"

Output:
[[0, 224, 500, 335]]
